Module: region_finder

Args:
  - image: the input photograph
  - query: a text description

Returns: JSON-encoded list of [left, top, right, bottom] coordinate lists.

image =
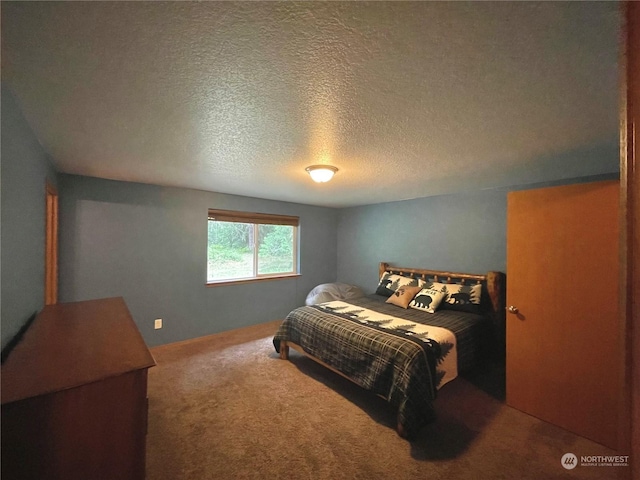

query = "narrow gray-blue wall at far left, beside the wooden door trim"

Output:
[[0, 86, 56, 347]]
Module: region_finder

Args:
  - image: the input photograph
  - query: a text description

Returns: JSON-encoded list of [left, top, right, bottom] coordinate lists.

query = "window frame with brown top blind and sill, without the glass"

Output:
[[206, 208, 300, 287]]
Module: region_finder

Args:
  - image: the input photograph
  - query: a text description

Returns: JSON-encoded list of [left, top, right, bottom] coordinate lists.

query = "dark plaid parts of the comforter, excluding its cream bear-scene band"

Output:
[[273, 295, 483, 436]]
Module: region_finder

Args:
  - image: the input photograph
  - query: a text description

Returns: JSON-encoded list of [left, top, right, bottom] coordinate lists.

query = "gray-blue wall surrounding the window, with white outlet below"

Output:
[[59, 175, 338, 346]]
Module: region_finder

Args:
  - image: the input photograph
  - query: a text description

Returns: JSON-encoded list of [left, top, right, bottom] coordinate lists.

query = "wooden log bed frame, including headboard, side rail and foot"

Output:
[[280, 262, 506, 438]]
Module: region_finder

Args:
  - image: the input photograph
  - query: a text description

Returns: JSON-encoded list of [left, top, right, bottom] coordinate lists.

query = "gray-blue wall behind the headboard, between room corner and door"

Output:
[[338, 189, 507, 292]]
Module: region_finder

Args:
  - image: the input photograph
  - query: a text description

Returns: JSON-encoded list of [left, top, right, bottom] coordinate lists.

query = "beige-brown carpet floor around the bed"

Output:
[[147, 322, 624, 480]]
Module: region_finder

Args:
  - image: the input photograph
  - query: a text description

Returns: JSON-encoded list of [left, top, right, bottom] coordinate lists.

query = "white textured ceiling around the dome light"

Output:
[[2, 1, 620, 206]]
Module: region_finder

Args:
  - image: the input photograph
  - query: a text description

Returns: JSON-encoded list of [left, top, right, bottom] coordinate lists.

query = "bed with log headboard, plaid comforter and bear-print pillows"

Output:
[[273, 262, 505, 439]]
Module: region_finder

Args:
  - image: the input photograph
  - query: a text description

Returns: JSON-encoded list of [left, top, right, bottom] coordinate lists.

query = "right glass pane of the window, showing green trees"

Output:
[[258, 225, 295, 275]]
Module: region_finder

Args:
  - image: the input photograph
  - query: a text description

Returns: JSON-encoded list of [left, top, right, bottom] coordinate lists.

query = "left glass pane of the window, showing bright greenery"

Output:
[[207, 220, 255, 281]]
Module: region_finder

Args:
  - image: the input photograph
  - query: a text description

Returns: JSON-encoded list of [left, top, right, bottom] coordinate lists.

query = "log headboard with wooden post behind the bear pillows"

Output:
[[379, 262, 507, 358]]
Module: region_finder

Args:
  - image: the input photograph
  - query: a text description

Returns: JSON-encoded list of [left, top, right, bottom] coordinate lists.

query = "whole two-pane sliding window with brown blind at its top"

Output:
[[207, 210, 299, 283]]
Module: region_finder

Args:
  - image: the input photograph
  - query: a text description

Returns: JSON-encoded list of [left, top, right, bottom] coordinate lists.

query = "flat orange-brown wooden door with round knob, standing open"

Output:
[[507, 181, 620, 448]]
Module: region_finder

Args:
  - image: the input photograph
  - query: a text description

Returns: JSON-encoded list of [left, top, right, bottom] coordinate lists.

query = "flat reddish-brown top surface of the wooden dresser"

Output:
[[1, 298, 155, 405]]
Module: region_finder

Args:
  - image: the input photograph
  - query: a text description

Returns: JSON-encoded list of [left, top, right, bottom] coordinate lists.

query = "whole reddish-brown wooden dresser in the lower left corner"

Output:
[[1, 298, 155, 480]]
